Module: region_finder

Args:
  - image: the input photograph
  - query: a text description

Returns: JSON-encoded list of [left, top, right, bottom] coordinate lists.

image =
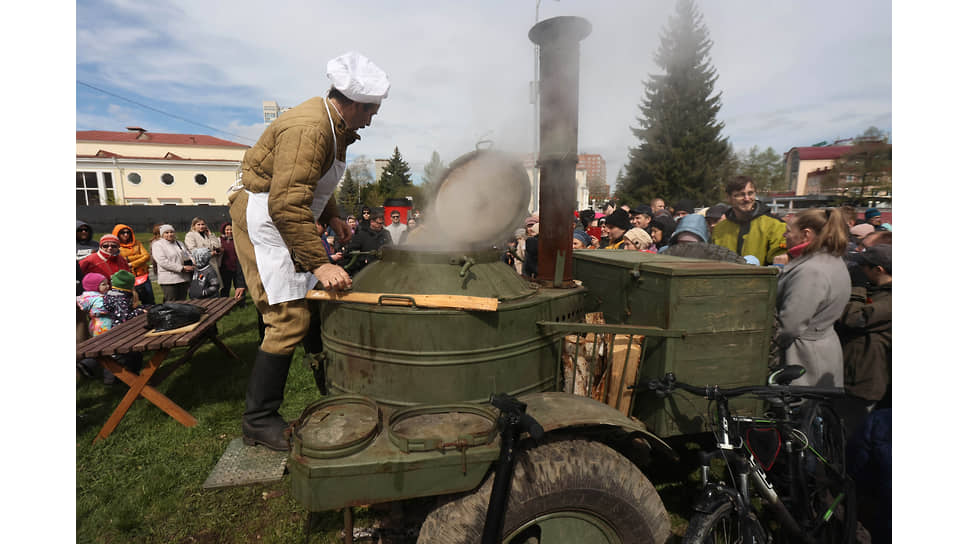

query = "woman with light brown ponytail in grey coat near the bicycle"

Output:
[[776, 208, 850, 387]]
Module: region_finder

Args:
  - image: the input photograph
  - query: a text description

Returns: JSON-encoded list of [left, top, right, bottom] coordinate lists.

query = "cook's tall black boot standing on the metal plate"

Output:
[[242, 349, 292, 451]]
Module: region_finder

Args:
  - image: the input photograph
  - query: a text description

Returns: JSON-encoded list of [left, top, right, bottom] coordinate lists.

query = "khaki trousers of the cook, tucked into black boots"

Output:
[[229, 190, 310, 355]]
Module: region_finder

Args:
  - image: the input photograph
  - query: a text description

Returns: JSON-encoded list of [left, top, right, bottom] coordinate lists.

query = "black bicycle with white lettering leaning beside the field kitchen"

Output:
[[647, 365, 857, 544]]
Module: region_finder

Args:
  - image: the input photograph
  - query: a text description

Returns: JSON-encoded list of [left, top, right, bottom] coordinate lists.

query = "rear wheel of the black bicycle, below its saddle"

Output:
[[800, 403, 857, 544]]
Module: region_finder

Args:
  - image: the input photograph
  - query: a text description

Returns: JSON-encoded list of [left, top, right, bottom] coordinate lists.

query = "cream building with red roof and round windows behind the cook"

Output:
[[76, 127, 249, 206]]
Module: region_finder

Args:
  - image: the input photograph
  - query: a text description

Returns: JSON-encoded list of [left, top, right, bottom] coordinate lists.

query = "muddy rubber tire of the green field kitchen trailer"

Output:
[[417, 439, 670, 544]]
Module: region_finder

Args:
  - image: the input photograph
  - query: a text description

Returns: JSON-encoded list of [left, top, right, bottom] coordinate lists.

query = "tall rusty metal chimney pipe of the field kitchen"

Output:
[[528, 16, 592, 287]]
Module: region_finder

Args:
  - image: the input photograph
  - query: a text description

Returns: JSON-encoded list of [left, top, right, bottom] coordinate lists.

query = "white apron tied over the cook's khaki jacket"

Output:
[[237, 105, 346, 304]]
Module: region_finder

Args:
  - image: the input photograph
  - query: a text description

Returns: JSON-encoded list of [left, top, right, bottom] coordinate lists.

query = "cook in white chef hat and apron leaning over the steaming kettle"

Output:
[[229, 52, 390, 451]]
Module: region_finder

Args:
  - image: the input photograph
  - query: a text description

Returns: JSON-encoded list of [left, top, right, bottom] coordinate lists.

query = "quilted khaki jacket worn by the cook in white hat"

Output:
[[233, 96, 359, 272]]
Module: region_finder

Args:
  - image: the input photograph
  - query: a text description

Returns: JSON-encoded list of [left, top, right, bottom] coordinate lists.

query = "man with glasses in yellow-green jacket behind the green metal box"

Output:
[[712, 176, 787, 266]]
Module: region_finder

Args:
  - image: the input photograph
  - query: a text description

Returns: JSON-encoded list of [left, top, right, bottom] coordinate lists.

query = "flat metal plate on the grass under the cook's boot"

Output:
[[202, 437, 288, 489]]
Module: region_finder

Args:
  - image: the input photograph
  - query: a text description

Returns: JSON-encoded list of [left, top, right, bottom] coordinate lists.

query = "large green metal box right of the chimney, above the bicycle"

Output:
[[574, 249, 777, 436]]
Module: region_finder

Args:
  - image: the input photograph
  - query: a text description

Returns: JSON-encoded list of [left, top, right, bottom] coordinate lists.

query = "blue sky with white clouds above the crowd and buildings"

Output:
[[76, 0, 892, 183]]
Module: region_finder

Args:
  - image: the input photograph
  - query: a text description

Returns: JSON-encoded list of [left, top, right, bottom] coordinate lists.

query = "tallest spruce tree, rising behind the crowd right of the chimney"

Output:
[[616, 0, 729, 203]]
